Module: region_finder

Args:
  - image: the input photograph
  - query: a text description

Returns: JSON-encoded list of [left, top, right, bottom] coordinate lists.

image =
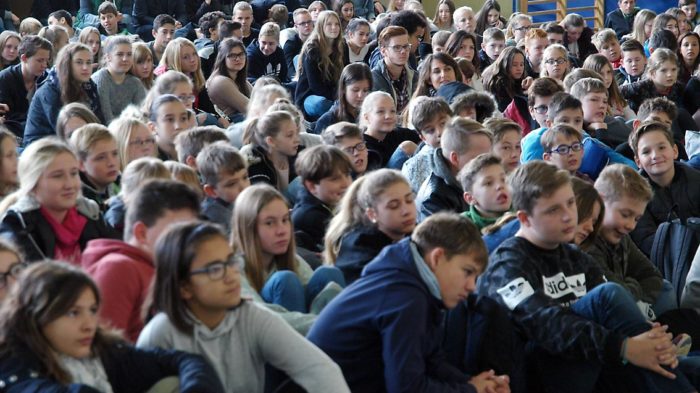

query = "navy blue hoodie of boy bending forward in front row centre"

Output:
[[308, 239, 476, 393]]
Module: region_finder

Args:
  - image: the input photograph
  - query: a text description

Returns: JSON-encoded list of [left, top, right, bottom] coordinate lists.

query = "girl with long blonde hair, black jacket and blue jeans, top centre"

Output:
[[294, 11, 344, 120]]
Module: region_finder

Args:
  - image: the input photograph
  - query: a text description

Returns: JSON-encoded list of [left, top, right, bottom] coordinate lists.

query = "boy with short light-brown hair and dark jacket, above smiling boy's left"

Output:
[[571, 78, 632, 148]]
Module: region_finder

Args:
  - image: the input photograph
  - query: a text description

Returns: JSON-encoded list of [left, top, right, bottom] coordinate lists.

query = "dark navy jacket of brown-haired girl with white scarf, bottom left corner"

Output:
[[0, 343, 224, 393]]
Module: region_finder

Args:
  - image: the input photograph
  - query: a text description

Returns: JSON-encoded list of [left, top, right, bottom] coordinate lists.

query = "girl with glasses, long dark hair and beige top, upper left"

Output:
[[207, 37, 253, 123]]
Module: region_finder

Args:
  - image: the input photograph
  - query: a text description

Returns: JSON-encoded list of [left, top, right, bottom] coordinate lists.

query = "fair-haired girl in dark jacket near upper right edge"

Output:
[[620, 48, 683, 112]]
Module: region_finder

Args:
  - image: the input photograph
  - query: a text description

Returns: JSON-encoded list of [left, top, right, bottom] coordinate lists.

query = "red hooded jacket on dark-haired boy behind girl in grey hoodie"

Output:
[[81, 239, 155, 343]]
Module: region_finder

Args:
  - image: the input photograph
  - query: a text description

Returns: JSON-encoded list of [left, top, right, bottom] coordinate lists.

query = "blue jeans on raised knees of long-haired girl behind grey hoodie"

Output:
[[260, 266, 345, 313]]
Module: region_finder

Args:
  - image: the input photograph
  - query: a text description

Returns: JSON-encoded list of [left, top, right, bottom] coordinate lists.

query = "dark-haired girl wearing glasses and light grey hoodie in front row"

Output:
[[137, 222, 349, 393]]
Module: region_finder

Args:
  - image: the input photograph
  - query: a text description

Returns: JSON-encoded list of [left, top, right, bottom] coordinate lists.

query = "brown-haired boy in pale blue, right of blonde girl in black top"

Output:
[[401, 97, 452, 192]]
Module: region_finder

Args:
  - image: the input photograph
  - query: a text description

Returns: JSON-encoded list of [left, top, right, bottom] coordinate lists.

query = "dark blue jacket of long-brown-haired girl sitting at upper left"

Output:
[[23, 68, 104, 147]]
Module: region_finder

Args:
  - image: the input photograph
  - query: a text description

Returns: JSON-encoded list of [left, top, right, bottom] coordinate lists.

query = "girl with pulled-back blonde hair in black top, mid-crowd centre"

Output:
[[360, 91, 420, 169]]
